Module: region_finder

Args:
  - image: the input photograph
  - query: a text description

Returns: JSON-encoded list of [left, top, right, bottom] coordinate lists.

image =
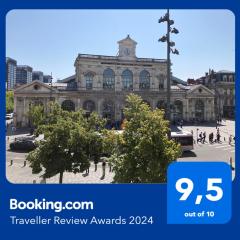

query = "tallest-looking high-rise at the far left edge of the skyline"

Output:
[[6, 57, 17, 90]]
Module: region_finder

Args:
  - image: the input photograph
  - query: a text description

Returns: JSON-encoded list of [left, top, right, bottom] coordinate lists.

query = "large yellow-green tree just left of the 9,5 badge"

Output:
[[111, 94, 181, 183]]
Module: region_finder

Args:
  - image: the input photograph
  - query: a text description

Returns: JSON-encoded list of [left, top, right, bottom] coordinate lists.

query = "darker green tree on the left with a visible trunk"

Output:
[[27, 104, 104, 183]]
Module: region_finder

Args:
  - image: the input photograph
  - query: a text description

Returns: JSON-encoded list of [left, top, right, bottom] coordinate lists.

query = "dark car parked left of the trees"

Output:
[[9, 137, 36, 152]]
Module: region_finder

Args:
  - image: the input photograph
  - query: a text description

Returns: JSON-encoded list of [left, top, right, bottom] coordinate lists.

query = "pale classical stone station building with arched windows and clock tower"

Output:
[[14, 36, 215, 126]]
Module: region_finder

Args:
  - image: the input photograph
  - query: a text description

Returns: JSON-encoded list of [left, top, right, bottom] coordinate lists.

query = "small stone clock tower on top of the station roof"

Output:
[[118, 35, 137, 60]]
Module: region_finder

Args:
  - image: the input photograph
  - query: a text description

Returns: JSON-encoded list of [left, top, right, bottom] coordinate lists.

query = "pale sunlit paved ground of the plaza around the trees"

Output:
[[6, 120, 235, 183]]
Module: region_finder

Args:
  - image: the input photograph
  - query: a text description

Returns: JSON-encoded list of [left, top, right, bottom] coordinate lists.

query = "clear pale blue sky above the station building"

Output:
[[6, 10, 235, 80]]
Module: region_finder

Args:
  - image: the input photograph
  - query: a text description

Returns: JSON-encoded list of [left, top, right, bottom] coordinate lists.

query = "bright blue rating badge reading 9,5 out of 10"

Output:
[[167, 162, 232, 224]]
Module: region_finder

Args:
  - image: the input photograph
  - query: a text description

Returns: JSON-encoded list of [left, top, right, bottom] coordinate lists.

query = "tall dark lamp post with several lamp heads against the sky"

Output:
[[158, 9, 179, 137]]
